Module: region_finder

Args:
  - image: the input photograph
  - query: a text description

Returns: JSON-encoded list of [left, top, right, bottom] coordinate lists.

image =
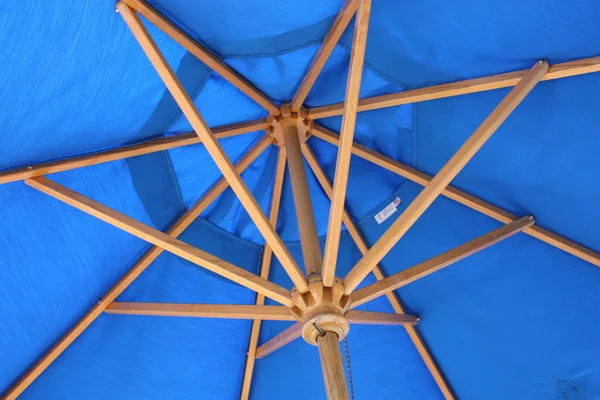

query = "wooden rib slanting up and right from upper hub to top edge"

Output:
[[290, 0, 358, 112]]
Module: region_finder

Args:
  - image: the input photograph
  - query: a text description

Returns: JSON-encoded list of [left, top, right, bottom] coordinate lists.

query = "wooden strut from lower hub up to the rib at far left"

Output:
[[25, 177, 293, 307]]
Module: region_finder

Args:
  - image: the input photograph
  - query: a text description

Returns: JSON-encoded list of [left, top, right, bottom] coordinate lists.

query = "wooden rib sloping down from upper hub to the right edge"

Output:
[[311, 125, 600, 267]]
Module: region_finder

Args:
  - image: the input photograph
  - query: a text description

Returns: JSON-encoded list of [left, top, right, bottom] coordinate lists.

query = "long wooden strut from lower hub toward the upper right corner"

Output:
[[340, 61, 548, 295]]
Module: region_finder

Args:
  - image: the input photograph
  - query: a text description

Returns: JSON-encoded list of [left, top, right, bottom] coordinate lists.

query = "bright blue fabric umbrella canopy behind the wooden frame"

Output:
[[0, 0, 600, 400]]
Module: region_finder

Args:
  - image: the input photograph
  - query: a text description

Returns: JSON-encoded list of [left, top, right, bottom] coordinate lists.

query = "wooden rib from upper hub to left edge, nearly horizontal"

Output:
[[0, 118, 267, 184]]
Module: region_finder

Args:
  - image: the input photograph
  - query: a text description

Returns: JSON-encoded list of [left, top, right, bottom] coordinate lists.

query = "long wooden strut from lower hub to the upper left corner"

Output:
[[117, 0, 308, 293]]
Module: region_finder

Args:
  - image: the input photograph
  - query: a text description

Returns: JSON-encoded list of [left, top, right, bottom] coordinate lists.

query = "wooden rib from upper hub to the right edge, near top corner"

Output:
[[307, 56, 600, 119]]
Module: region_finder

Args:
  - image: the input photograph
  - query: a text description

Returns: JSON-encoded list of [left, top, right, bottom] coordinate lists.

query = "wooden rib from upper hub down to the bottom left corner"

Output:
[[2, 137, 271, 400]]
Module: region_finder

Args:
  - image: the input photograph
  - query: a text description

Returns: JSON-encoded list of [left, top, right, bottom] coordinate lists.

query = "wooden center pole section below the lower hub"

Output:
[[317, 332, 349, 400]]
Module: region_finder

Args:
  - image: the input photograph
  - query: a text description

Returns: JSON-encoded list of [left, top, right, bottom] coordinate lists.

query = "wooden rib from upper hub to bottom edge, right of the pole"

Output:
[[302, 143, 455, 400]]
